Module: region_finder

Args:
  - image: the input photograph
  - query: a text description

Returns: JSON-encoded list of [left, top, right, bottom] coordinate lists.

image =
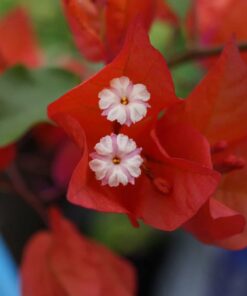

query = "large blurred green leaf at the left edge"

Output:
[[0, 66, 78, 146]]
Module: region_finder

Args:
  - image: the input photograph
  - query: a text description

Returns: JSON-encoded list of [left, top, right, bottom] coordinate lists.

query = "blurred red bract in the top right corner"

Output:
[[187, 0, 247, 61]]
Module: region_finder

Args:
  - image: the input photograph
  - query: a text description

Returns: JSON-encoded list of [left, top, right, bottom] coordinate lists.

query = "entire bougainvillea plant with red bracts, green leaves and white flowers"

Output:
[[0, 0, 247, 296]]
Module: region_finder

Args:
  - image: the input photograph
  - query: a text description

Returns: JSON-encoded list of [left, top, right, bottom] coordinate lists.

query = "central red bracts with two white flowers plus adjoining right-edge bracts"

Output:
[[49, 5, 246, 248]]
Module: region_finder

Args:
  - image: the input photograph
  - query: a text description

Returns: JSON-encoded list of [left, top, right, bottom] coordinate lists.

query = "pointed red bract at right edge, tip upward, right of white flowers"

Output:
[[167, 41, 247, 145]]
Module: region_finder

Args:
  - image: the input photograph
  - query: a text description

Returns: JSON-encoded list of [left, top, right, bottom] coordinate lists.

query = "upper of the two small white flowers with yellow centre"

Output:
[[99, 76, 150, 126]]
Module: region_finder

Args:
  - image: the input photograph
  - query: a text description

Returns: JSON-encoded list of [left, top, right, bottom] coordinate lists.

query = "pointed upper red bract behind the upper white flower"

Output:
[[48, 20, 177, 149]]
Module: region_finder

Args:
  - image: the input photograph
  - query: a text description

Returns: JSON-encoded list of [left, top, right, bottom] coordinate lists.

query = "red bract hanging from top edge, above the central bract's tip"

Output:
[[63, 0, 175, 62]]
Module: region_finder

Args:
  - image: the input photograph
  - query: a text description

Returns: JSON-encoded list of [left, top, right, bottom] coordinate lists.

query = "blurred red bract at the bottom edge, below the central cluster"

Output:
[[21, 210, 136, 296]]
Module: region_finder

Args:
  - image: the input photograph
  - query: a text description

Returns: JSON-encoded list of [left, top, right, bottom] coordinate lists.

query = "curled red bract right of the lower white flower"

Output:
[[140, 123, 219, 230]]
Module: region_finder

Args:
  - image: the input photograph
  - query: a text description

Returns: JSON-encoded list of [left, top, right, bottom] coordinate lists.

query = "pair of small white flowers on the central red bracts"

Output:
[[89, 76, 150, 187]]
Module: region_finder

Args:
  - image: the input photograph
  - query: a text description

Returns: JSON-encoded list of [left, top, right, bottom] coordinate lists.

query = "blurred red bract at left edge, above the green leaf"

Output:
[[0, 9, 40, 71]]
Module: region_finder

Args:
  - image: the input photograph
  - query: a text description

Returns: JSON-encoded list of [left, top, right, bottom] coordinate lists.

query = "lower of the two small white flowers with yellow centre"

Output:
[[89, 134, 143, 187]]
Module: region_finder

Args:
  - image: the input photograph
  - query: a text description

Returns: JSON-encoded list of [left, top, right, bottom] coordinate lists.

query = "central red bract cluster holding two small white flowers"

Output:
[[48, 21, 219, 230]]
